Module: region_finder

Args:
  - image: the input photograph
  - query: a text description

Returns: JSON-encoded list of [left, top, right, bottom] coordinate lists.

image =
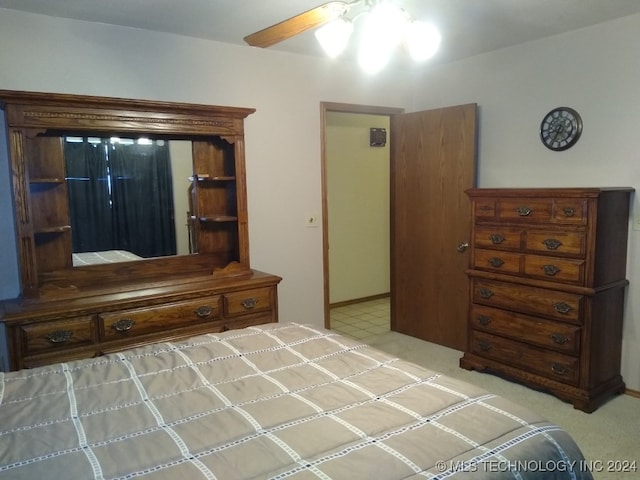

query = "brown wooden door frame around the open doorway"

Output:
[[320, 102, 404, 328]]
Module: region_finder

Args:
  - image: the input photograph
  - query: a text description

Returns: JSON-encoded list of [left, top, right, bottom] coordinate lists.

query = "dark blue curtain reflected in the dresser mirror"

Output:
[[65, 139, 176, 258]]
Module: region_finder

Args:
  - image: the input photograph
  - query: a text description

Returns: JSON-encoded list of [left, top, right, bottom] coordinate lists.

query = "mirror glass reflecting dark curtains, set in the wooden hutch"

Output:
[[63, 135, 196, 267]]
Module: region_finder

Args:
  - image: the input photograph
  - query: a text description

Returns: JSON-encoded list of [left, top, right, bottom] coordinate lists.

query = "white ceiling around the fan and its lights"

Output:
[[0, 0, 640, 67]]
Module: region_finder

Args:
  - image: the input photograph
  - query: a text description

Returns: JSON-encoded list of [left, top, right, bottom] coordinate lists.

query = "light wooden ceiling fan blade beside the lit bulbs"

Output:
[[244, 2, 349, 48]]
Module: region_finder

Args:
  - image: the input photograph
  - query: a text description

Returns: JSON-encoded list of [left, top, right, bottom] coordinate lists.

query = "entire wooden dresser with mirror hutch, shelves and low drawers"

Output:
[[0, 91, 281, 370]]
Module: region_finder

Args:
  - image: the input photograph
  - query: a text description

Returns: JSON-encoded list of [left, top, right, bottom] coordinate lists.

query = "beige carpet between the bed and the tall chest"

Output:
[[367, 332, 640, 480]]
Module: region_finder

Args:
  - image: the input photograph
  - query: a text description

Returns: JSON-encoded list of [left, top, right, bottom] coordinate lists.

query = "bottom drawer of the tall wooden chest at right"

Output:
[[471, 330, 580, 385]]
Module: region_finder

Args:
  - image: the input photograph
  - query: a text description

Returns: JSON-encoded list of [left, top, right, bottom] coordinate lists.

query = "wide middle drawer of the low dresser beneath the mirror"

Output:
[[98, 295, 221, 340]]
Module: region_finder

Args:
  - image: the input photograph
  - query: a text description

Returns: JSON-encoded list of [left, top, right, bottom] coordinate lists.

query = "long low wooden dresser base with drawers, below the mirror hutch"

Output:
[[1, 271, 280, 370]]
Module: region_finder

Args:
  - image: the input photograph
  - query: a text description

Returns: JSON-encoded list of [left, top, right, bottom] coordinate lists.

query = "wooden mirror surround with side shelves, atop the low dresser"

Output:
[[0, 90, 255, 299]]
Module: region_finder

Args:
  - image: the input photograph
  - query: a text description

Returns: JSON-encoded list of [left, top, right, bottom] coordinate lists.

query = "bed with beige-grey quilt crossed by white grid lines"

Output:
[[0, 323, 592, 480]]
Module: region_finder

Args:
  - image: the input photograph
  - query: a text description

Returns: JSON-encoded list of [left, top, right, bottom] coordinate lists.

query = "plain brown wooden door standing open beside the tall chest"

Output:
[[391, 104, 477, 350]]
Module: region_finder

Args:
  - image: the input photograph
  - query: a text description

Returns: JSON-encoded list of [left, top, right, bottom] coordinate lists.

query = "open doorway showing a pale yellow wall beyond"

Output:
[[321, 103, 402, 334]]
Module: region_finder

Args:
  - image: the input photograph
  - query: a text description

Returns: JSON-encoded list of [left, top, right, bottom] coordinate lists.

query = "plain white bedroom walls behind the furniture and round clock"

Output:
[[0, 9, 640, 390]]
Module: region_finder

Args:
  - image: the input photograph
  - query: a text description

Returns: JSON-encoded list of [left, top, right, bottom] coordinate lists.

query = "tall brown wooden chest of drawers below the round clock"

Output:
[[460, 188, 633, 412]]
